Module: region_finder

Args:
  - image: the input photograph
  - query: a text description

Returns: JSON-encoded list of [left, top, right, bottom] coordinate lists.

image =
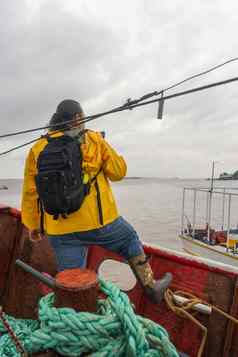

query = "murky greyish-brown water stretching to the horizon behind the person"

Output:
[[0, 178, 238, 250]]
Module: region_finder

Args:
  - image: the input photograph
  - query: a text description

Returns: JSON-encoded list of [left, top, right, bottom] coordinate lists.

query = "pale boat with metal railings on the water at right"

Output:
[[179, 187, 238, 267]]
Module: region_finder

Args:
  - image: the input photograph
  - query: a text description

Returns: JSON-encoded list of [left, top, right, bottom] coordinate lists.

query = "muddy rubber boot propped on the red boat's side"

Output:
[[128, 254, 173, 304]]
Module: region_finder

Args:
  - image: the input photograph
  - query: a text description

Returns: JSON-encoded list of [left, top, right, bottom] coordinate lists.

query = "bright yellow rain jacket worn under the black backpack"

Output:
[[22, 131, 127, 235]]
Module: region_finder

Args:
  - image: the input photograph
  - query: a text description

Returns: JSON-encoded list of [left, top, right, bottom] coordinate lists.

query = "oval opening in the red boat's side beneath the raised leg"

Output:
[[98, 259, 136, 291]]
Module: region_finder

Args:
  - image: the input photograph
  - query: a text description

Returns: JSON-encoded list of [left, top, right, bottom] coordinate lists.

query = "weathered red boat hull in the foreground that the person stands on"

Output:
[[0, 206, 238, 357]]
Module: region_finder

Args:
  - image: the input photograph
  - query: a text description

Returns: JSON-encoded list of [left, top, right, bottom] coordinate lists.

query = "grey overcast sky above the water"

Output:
[[0, 0, 238, 178]]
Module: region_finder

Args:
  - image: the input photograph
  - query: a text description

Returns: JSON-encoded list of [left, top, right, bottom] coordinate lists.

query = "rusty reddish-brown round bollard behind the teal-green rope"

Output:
[[54, 269, 99, 313]]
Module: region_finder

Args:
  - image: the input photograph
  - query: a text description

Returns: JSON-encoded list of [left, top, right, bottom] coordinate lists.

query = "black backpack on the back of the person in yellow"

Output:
[[36, 135, 90, 219]]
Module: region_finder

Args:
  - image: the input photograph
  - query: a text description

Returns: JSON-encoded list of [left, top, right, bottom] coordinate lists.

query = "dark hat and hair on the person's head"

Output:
[[49, 99, 83, 130]]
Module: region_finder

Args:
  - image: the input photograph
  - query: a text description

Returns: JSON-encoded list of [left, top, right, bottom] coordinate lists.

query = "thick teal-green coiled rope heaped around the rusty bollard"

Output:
[[0, 280, 179, 357]]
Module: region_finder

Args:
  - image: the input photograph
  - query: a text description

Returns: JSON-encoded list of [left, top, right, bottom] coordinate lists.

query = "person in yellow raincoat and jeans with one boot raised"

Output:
[[22, 99, 172, 303]]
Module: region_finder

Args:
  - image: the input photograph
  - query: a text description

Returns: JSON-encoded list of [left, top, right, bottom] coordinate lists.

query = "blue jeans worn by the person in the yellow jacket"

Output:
[[47, 217, 143, 271]]
